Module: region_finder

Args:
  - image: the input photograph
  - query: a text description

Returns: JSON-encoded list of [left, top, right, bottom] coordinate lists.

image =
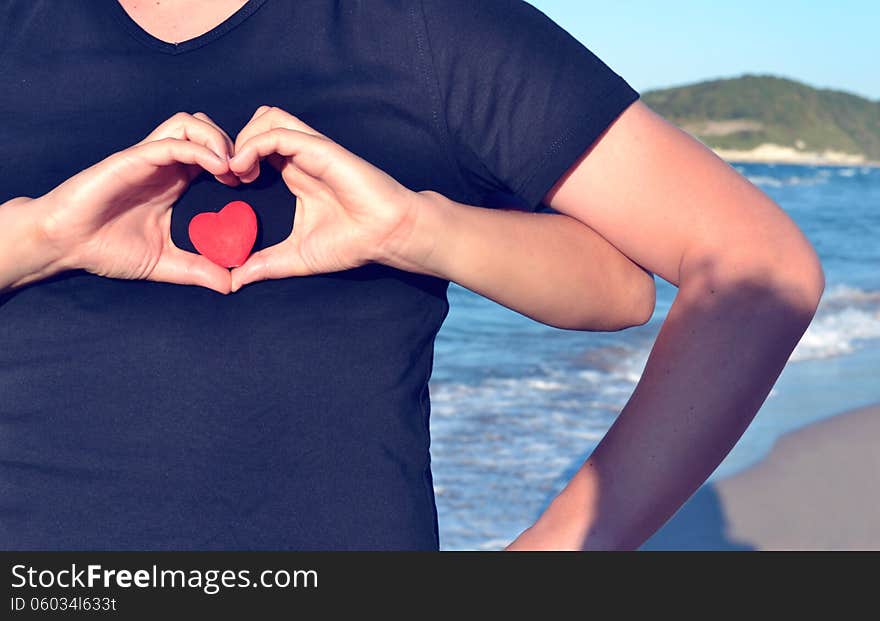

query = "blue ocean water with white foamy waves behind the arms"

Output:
[[430, 163, 880, 550]]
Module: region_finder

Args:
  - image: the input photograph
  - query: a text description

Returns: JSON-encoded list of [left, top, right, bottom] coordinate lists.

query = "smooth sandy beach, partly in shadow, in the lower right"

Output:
[[642, 404, 880, 550]]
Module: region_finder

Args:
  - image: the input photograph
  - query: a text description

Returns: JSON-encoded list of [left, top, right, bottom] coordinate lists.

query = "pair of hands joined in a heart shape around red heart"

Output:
[[39, 106, 422, 294]]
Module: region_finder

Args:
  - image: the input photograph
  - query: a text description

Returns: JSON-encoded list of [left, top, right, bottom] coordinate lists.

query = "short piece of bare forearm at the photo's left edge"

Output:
[[0, 197, 63, 292]]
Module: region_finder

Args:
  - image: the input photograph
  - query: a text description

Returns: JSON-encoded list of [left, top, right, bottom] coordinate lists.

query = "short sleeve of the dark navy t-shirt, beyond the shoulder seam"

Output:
[[422, 0, 639, 210]]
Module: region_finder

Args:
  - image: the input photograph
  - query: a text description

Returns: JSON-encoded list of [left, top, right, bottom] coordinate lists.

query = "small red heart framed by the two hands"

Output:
[[189, 201, 257, 267]]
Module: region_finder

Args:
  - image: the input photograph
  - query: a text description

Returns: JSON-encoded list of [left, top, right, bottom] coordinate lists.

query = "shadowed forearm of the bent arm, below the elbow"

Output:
[[511, 252, 821, 549]]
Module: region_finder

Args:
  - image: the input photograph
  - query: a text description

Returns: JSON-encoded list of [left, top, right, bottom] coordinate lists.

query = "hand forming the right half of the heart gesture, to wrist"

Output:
[[229, 106, 419, 291]]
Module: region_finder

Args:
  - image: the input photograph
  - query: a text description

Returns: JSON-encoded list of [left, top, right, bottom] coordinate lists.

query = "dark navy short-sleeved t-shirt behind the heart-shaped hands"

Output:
[[0, 0, 638, 549]]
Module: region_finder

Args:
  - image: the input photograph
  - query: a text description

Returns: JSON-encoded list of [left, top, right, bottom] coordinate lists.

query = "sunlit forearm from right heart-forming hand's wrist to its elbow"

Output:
[[383, 192, 654, 330]]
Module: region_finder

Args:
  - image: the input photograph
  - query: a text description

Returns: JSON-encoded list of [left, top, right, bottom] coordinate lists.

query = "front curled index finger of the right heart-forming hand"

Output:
[[229, 128, 338, 187]]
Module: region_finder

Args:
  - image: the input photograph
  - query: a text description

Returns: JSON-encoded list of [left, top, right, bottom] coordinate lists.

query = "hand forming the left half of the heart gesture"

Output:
[[34, 113, 239, 294]]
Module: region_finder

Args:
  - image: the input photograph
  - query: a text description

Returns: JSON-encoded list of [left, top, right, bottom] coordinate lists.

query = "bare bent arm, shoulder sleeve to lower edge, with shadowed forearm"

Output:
[[509, 102, 824, 549]]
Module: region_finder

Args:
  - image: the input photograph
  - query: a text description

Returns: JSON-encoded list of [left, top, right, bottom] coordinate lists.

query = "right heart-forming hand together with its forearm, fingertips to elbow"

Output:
[[230, 106, 654, 330]]
